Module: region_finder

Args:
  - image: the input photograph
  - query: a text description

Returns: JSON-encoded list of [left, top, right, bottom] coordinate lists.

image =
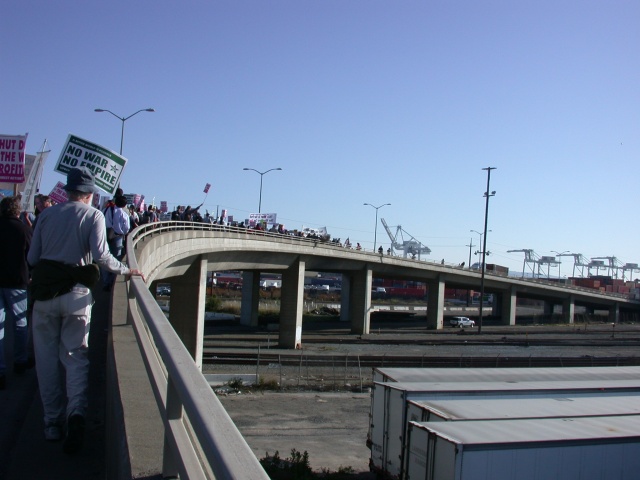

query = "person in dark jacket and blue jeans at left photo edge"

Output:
[[0, 197, 32, 390]]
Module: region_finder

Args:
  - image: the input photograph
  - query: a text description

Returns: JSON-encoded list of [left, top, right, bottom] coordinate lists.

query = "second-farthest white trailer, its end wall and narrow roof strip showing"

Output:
[[368, 380, 640, 476]]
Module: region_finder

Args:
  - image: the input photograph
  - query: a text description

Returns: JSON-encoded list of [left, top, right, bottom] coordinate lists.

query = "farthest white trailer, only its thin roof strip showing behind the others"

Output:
[[373, 367, 640, 382]]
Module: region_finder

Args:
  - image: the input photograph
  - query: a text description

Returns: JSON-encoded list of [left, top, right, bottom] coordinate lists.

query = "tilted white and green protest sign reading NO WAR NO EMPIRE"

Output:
[[54, 135, 127, 195]]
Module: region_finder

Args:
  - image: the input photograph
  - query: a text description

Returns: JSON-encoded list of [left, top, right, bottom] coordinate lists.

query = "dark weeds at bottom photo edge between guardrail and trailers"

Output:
[[260, 448, 356, 480]]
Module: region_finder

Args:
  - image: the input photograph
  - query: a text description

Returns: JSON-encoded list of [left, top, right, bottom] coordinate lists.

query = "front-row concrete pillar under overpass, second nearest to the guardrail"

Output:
[[278, 260, 305, 348]]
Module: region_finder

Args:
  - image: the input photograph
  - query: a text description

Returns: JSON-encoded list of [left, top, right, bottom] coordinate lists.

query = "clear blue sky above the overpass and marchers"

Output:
[[0, 0, 640, 276]]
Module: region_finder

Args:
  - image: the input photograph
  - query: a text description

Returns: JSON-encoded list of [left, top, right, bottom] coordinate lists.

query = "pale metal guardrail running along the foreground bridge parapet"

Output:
[[127, 222, 269, 480]]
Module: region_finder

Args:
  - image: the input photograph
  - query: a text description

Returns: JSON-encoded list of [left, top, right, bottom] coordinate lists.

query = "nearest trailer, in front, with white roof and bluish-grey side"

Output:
[[407, 416, 640, 480]]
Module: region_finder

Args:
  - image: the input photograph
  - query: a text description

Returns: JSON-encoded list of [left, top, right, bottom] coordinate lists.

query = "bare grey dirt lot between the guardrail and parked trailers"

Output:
[[219, 392, 374, 478]]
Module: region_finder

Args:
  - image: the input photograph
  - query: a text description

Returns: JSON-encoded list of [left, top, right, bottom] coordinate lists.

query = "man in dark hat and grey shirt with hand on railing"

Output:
[[27, 167, 142, 454]]
